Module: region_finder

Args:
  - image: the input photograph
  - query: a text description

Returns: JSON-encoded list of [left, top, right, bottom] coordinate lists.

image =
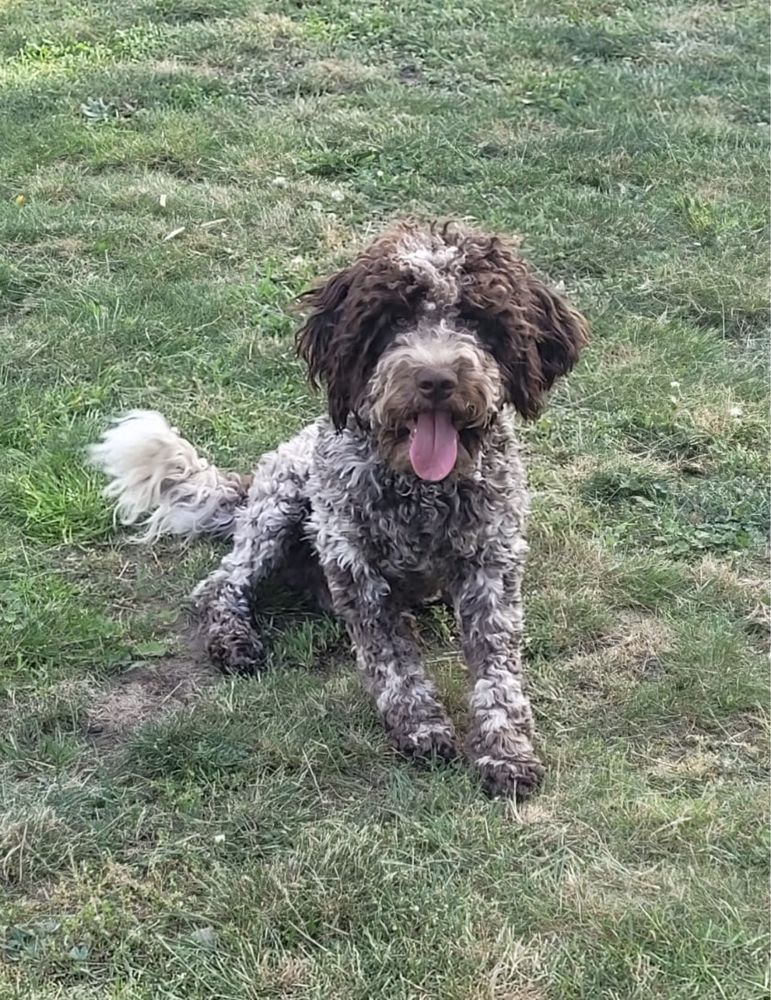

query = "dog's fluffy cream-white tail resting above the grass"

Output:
[[89, 410, 252, 542]]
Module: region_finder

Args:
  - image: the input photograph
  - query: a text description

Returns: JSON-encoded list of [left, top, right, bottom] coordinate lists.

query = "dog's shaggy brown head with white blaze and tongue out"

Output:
[[297, 223, 587, 480]]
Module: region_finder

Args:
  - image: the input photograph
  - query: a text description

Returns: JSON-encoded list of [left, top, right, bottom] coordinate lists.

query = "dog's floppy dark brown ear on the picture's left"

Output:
[[297, 246, 419, 430]]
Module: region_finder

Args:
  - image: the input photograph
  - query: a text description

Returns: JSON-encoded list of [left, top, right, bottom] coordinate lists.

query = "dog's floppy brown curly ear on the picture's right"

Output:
[[461, 237, 589, 419]]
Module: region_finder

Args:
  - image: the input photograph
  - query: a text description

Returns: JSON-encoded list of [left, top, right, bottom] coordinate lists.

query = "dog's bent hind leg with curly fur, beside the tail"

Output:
[[193, 425, 316, 674]]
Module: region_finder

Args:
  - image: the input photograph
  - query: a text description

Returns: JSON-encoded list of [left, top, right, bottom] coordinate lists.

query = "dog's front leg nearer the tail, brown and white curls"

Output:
[[324, 562, 456, 759]]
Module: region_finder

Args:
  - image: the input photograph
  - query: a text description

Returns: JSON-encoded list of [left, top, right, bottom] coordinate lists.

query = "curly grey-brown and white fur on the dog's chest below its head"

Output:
[[309, 421, 527, 601]]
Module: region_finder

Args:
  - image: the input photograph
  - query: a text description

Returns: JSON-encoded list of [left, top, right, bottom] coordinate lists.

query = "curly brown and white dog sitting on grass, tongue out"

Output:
[[91, 222, 587, 796]]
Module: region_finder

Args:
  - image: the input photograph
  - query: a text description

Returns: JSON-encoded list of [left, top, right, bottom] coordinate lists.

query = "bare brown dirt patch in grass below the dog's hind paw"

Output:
[[86, 654, 219, 750]]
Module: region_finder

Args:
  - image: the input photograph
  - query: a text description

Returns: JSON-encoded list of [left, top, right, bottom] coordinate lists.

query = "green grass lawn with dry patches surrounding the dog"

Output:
[[0, 0, 768, 1000]]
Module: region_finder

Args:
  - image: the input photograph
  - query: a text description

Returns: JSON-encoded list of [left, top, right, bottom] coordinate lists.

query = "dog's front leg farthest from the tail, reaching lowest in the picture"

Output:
[[452, 565, 544, 798]]
